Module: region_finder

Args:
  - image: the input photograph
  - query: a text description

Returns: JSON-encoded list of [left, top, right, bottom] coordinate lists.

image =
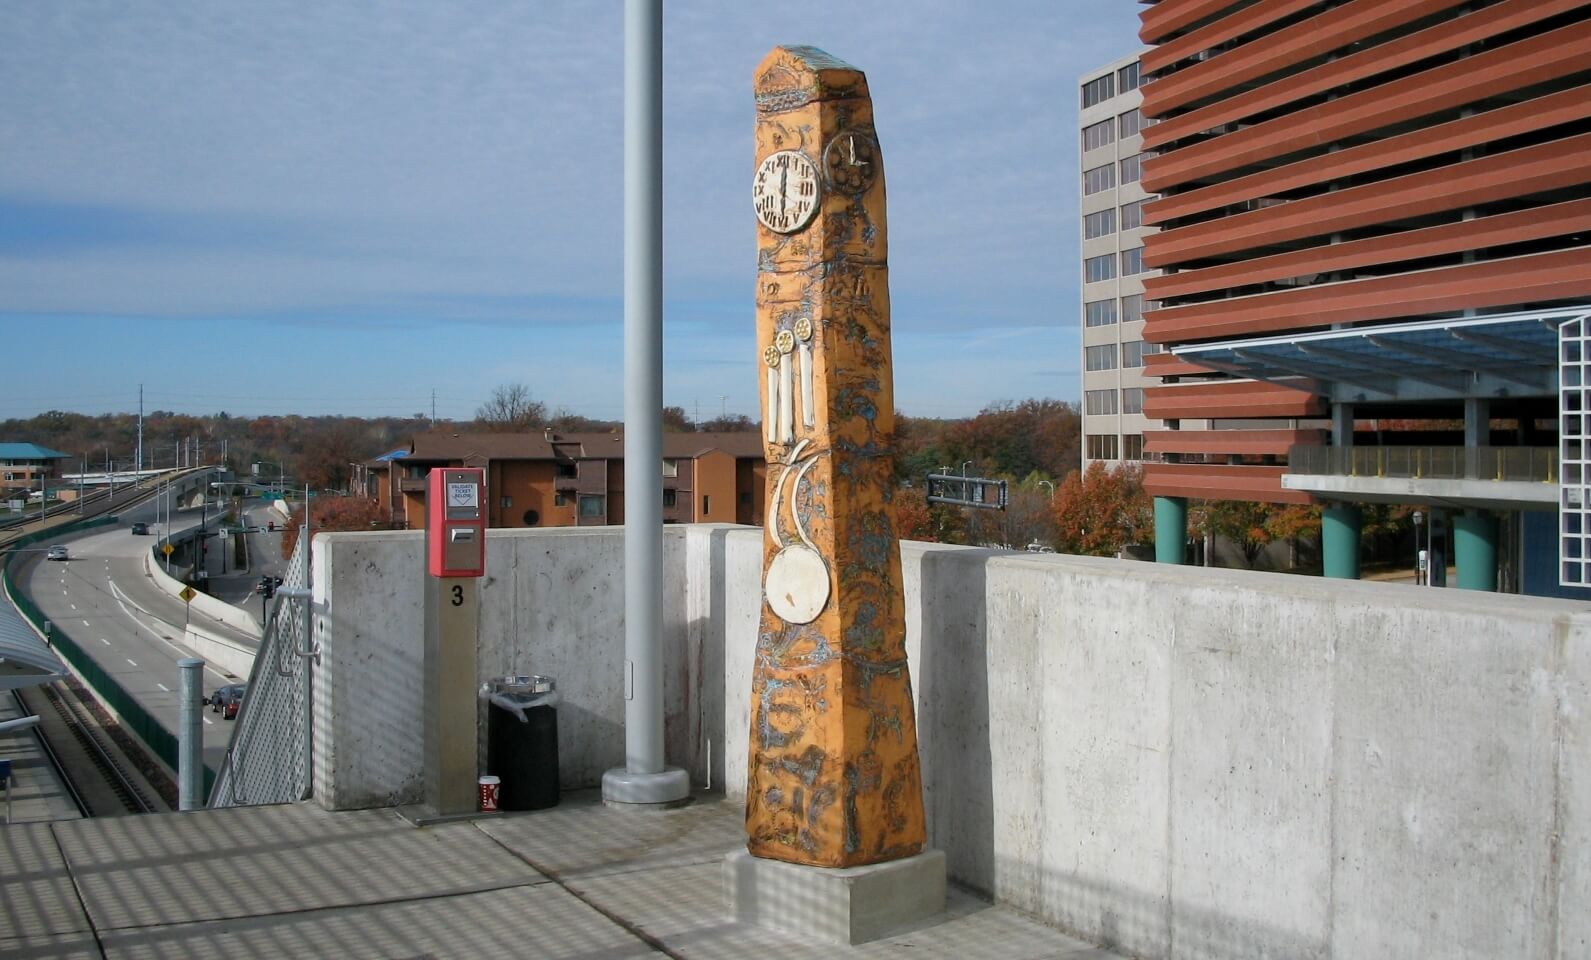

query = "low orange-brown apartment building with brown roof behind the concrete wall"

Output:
[[355, 431, 767, 529]]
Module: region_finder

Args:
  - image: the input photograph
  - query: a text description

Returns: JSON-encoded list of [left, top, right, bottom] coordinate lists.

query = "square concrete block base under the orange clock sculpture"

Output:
[[724, 850, 945, 944]]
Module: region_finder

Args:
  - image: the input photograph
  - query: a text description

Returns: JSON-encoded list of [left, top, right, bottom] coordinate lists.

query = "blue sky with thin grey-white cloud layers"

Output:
[[0, 0, 1141, 419]]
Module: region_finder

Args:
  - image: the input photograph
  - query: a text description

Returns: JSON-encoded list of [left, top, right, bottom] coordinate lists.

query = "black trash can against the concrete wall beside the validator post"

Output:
[[487, 677, 558, 810]]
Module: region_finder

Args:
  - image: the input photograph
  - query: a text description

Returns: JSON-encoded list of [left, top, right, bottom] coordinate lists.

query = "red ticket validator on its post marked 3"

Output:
[[414, 466, 487, 823]]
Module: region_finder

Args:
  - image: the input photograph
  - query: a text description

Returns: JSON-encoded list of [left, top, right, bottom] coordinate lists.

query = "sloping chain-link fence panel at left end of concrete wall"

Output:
[[210, 530, 320, 807]]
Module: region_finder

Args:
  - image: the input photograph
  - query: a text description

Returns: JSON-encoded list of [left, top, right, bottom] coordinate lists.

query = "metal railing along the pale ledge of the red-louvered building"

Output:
[[1287, 444, 1558, 484]]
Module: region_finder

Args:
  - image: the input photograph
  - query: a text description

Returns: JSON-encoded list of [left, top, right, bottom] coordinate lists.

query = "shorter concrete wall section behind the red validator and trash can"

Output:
[[312, 527, 706, 809]]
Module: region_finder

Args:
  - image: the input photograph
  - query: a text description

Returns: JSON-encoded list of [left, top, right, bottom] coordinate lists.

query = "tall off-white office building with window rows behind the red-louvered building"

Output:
[[1077, 54, 1158, 468]]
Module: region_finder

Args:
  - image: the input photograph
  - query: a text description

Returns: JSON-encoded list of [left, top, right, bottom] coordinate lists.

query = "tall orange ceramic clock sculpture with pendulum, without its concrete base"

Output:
[[746, 46, 924, 868]]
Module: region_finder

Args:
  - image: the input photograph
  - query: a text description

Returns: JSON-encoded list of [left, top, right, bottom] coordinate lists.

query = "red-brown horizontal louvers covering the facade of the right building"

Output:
[[1139, 0, 1591, 501]]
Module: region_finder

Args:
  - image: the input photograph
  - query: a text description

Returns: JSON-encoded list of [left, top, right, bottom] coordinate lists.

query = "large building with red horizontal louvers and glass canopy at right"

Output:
[[1139, 0, 1591, 592]]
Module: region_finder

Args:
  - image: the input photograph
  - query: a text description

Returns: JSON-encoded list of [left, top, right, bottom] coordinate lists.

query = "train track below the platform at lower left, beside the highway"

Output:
[[14, 680, 165, 817]]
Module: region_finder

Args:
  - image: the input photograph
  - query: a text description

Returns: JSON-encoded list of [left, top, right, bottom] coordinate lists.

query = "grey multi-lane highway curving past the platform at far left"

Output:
[[16, 483, 282, 769]]
